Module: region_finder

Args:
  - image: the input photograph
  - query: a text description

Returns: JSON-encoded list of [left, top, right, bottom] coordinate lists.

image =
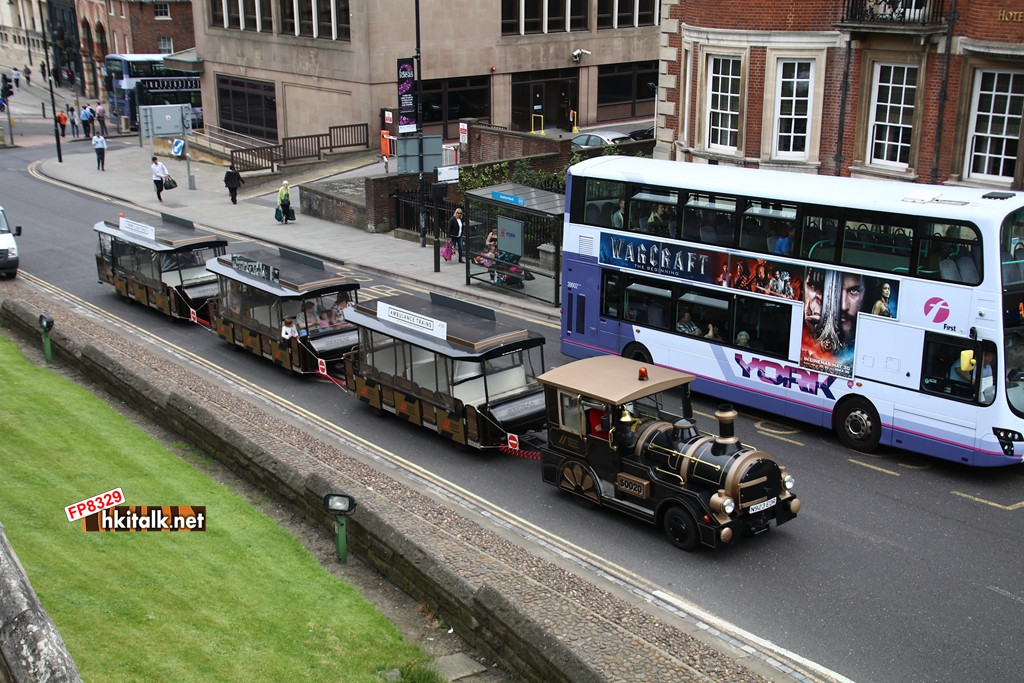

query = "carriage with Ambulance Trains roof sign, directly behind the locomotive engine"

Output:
[[345, 295, 545, 450]]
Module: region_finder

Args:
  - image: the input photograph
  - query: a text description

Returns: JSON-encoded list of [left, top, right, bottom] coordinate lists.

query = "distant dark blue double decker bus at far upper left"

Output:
[[103, 54, 203, 129]]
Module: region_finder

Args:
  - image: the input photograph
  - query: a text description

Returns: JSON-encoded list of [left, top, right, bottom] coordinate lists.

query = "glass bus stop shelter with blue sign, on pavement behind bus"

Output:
[[465, 182, 565, 306]]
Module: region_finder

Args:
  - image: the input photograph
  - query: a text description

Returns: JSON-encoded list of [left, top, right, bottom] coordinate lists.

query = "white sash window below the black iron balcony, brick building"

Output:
[[867, 62, 918, 168]]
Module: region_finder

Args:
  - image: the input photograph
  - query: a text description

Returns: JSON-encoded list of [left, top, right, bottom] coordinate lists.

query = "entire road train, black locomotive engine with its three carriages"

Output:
[[94, 217, 801, 551]]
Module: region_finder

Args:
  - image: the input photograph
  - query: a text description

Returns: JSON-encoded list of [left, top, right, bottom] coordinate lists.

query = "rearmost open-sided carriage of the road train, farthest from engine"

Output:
[[93, 216, 227, 325]]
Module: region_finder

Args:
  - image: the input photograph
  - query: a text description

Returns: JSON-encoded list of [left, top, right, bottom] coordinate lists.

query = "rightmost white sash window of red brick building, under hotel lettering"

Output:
[[965, 71, 1024, 181]]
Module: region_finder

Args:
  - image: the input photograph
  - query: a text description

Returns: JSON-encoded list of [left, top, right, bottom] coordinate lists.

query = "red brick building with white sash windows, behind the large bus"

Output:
[[655, 0, 1024, 189]]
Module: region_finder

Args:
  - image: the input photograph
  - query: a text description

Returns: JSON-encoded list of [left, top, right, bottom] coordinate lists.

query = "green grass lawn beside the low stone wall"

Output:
[[0, 338, 439, 682]]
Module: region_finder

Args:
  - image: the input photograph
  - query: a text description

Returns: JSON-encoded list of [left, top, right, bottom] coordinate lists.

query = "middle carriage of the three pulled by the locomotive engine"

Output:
[[206, 248, 359, 377]]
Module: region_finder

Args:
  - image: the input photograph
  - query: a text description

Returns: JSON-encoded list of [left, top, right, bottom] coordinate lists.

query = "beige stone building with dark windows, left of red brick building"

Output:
[[193, 0, 660, 140]]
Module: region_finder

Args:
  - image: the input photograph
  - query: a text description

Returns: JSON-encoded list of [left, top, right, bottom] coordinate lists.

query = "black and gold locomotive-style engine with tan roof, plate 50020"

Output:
[[538, 356, 800, 550]]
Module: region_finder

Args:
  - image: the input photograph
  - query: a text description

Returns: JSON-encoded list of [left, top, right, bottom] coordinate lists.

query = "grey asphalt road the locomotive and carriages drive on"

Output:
[[6, 123, 1024, 682]]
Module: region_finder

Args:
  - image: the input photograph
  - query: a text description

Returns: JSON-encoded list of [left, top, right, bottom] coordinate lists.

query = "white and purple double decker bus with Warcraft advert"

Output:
[[561, 157, 1024, 467]]
